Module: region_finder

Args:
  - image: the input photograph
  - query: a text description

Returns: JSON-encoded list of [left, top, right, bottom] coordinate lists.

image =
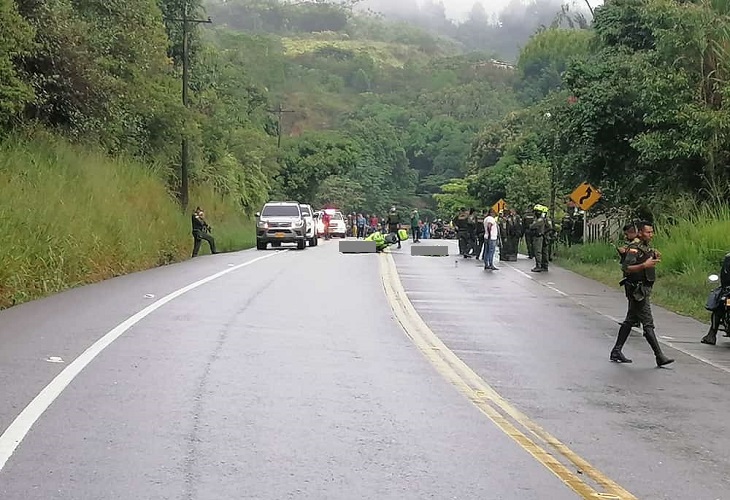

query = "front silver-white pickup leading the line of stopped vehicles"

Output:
[[256, 201, 307, 250]]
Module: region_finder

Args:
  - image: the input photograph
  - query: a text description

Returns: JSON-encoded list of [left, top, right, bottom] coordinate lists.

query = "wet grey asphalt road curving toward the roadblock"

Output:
[[0, 237, 730, 500]]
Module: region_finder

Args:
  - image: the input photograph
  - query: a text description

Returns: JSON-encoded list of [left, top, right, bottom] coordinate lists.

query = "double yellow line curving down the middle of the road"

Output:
[[380, 254, 636, 500]]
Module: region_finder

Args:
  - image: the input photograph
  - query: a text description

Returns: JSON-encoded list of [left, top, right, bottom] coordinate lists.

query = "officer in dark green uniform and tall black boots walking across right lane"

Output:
[[610, 222, 674, 366]]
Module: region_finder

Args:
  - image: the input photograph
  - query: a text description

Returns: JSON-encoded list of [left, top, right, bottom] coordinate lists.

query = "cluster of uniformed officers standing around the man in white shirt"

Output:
[[452, 204, 557, 273]]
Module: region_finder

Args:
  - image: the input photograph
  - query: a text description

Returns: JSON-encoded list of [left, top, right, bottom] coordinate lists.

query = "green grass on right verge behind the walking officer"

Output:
[[556, 206, 730, 323]]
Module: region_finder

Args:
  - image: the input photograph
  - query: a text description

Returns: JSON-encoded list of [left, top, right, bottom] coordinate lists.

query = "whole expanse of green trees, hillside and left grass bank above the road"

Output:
[[0, 0, 730, 312]]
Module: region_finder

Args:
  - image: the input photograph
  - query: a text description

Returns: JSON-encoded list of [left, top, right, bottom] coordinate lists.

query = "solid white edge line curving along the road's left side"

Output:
[[0, 249, 288, 471]]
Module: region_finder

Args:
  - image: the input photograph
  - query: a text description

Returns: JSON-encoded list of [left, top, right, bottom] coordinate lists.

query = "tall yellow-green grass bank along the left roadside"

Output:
[[0, 133, 255, 308]]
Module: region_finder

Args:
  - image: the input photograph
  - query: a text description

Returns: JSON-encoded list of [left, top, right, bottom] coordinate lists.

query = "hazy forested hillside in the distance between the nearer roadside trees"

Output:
[[196, 0, 527, 206]]
